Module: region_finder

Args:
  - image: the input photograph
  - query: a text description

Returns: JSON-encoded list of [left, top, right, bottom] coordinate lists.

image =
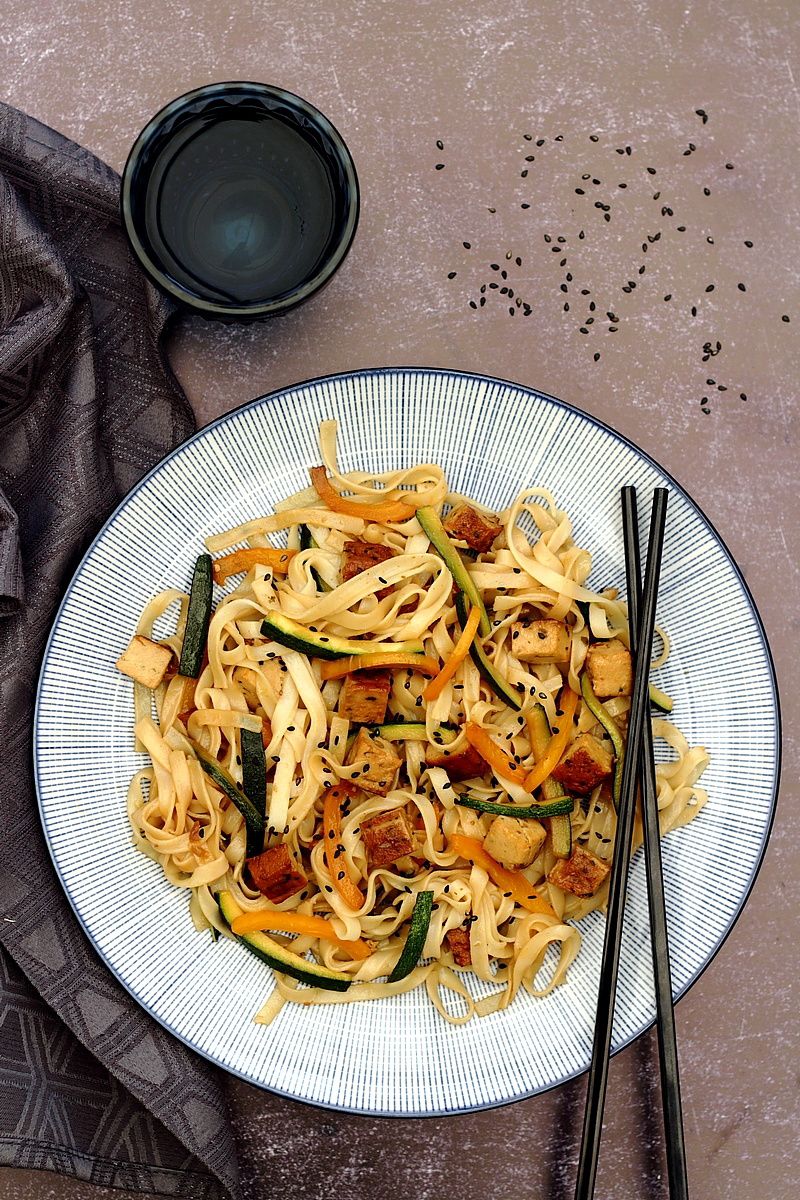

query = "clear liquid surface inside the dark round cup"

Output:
[[137, 107, 342, 305]]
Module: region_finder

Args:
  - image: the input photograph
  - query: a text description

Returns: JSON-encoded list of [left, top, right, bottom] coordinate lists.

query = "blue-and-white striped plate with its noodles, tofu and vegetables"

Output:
[[35, 370, 778, 1115]]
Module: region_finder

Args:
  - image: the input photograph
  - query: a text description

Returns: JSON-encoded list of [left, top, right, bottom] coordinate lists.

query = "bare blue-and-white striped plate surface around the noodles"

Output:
[[35, 368, 780, 1115]]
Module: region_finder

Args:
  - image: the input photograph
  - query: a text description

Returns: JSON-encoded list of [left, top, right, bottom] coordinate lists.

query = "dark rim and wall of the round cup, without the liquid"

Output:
[[120, 79, 361, 319]]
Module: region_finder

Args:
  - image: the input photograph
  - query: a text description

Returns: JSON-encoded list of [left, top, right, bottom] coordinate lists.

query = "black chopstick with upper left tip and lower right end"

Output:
[[622, 487, 688, 1200]]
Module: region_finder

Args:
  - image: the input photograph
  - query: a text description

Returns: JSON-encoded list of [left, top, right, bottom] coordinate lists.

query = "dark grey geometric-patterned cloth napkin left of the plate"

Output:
[[0, 104, 240, 1200]]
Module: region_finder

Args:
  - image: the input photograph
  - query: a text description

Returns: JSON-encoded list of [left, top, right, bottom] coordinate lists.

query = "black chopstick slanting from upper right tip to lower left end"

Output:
[[575, 487, 667, 1200]]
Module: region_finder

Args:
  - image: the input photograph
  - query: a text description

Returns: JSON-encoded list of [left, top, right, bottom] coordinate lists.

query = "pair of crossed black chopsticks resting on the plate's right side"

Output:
[[575, 487, 688, 1200]]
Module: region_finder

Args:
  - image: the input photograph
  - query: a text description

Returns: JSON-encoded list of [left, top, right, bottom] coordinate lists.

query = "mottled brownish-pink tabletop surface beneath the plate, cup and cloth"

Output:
[[0, 0, 800, 1200]]
